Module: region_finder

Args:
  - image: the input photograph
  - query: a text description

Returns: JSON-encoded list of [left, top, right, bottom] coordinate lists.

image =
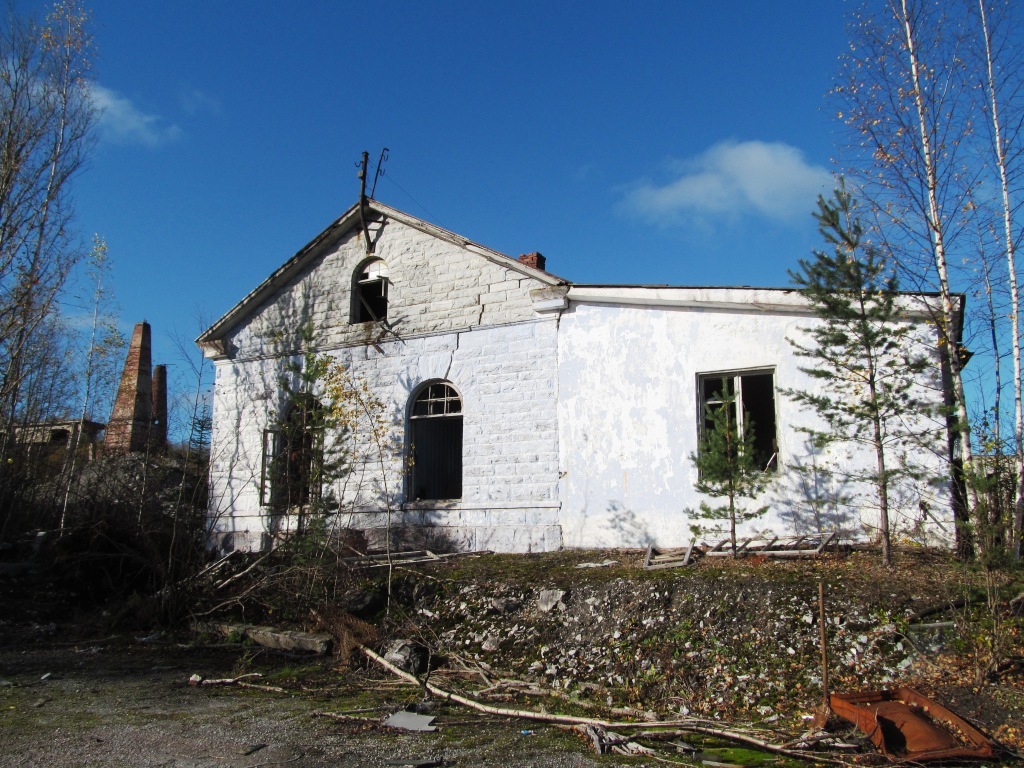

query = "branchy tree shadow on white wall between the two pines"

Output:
[[773, 442, 860, 536]]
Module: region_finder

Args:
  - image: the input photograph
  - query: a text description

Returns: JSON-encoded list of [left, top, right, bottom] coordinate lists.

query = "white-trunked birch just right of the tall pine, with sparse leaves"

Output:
[[834, 0, 983, 556]]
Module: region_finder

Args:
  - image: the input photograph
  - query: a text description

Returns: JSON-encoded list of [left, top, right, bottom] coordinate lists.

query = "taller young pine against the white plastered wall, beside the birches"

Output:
[[785, 186, 935, 565]]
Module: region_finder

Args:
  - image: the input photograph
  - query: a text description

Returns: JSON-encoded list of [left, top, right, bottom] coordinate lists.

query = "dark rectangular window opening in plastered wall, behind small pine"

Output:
[[697, 371, 778, 472]]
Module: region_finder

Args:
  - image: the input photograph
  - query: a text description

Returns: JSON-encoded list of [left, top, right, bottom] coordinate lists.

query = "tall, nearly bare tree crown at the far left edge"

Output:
[[0, 0, 96, 458]]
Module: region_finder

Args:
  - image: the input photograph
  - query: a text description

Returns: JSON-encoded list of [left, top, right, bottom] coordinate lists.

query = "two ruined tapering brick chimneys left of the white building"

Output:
[[103, 321, 167, 455]]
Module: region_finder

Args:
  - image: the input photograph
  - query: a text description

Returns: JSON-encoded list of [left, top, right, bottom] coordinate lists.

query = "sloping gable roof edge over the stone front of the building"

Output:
[[196, 199, 568, 346]]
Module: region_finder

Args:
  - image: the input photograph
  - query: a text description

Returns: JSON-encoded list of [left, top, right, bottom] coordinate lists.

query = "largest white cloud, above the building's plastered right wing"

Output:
[[621, 141, 835, 225]]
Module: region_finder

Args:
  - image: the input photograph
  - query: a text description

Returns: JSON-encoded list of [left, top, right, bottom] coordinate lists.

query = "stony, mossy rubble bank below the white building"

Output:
[[403, 556, 995, 719]]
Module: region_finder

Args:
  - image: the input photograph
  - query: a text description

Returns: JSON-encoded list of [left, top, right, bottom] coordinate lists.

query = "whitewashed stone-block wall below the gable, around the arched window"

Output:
[[211, 318, 561, 552]]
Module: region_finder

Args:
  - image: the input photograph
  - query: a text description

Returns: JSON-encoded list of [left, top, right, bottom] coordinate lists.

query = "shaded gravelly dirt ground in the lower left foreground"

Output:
[[0, 638, 622, 768]]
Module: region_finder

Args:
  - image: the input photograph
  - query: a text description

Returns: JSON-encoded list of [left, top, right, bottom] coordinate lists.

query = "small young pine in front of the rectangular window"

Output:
[[689, 378, 771, 557]]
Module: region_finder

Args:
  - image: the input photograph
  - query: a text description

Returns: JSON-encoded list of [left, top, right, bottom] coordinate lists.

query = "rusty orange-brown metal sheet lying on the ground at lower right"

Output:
[[829, 688, 995, 762]]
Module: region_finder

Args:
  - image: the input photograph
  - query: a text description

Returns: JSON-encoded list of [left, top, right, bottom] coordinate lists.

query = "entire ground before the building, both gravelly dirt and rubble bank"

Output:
[[0, 552, 1024, 768]]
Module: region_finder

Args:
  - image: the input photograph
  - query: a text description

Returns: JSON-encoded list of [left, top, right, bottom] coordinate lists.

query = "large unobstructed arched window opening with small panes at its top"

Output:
[[409, 381, 462, 501]]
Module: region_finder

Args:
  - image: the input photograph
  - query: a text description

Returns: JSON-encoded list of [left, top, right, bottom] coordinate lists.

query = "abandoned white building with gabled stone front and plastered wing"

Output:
[[197, 200, 953, 552]]
